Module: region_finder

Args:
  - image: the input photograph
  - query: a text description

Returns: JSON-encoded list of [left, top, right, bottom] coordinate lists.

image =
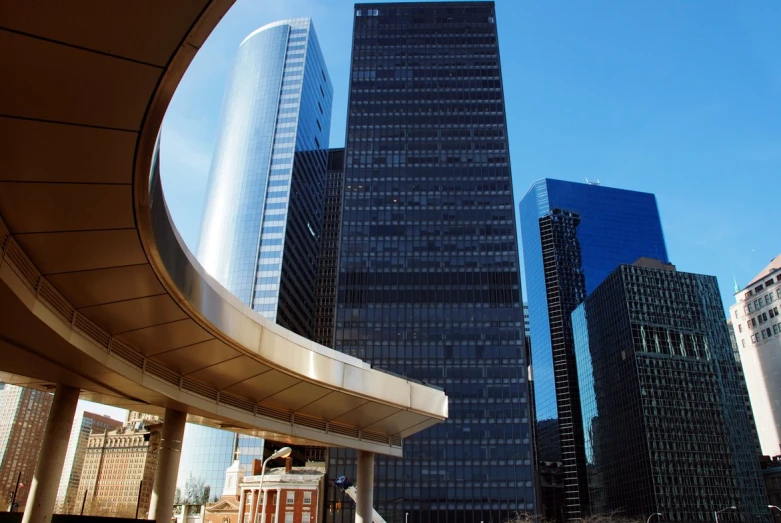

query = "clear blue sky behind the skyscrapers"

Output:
[[162, 0, 781, 307]]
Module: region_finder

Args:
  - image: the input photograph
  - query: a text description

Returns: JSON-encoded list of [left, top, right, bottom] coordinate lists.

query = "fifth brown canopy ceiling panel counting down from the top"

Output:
[[12, 229, 147, 274]]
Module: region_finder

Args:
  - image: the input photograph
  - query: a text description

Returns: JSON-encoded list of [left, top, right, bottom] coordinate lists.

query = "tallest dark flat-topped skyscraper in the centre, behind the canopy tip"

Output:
[[329, 2, 534, 523]]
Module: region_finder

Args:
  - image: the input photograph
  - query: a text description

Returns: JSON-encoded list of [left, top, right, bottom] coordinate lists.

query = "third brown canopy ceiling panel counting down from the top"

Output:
[[0, 116, 137, 183]]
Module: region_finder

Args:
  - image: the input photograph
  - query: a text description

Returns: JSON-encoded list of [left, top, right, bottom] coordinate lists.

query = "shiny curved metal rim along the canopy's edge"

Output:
[[127, 0, 448, 420]]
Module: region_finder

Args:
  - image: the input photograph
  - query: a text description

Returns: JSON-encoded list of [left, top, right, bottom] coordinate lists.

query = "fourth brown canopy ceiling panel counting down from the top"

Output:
[[0, 182, 135, 234]]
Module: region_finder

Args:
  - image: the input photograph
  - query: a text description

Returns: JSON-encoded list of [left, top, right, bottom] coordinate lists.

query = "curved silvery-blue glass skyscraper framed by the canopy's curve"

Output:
[[192, 18, 333, 492]]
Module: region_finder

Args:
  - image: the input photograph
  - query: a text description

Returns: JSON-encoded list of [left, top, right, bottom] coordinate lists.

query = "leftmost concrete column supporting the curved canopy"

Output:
[[22, 383, 81, 523]]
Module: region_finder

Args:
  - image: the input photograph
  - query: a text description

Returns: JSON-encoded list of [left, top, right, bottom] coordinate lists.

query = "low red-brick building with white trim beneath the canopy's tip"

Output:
[[204, 458, 325, 523]]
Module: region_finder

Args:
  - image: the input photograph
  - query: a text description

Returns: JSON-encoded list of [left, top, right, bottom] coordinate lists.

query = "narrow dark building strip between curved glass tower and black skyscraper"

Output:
[[314, 149, 344, 347]]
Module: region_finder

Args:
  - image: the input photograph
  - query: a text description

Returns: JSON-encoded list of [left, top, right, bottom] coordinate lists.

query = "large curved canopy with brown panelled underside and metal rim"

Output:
[[0, 0, 447, 455]]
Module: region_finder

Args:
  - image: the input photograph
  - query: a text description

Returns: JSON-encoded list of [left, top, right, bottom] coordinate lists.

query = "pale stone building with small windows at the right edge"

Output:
[[729, 254, 781, 456]]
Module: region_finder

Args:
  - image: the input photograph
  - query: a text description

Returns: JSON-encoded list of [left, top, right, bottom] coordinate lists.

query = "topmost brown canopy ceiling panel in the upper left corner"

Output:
[[0, 0, 206, 67]]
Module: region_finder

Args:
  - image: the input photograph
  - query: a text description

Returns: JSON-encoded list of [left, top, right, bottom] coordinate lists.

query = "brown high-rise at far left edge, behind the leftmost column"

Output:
[[0, 385, 52, 511]]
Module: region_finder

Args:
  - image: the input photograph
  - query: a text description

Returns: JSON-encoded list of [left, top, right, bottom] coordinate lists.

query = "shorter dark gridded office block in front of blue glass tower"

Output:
[[572, 258, 770, 522]]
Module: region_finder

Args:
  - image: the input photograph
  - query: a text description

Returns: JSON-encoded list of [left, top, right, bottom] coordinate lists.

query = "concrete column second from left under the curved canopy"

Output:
[[149, 409, 187, 523]]
